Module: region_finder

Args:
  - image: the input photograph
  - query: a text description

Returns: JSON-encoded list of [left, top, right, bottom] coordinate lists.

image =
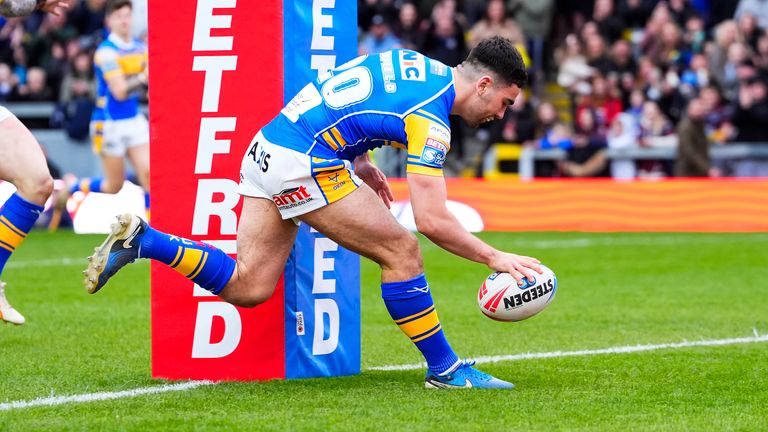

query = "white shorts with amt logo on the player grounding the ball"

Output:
[[237, 131, 363, 219]]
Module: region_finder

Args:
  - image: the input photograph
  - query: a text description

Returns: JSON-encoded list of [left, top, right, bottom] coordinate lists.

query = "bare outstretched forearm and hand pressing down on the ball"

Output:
[[408, 173, 541, 283]]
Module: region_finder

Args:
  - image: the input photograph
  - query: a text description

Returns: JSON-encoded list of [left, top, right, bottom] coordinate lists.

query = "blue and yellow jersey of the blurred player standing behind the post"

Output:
[[92, 34, 147, 121]]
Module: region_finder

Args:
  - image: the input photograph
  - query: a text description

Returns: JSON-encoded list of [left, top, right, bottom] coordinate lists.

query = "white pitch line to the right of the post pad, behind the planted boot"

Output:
[[368, 330, 768, 371]]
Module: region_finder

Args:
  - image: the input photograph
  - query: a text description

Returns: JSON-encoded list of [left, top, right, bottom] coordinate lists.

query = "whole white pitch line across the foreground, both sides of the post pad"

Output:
[[0, 329, 768, 411]]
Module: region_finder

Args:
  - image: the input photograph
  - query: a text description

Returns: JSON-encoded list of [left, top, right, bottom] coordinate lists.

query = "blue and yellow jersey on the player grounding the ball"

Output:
[[262, 49, 455, 176]]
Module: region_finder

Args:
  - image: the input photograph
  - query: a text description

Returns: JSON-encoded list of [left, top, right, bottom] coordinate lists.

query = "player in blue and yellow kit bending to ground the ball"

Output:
[[84, 37, 540, 388]]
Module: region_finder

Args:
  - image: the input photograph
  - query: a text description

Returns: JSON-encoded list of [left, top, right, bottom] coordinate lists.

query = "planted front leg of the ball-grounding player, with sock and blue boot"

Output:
[[299, 185, 513, 388]]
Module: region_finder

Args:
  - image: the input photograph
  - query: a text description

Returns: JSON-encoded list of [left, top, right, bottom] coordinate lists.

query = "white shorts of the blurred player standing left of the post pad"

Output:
[[91, 114, 149, 157]]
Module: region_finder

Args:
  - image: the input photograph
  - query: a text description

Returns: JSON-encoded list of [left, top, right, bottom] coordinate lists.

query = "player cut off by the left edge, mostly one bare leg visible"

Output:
[[0, 0, 69, 324]]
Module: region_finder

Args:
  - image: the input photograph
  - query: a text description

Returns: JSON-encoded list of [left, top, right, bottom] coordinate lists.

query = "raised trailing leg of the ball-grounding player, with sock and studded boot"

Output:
[[85, 197, 297, 300]]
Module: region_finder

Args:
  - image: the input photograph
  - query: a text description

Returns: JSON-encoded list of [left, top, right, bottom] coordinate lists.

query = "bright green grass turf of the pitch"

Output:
[[0, 232, 768, 431]]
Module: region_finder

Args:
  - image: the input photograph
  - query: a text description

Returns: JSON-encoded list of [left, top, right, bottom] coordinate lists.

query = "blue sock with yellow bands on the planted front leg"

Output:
[[381, 274, 459, 374]]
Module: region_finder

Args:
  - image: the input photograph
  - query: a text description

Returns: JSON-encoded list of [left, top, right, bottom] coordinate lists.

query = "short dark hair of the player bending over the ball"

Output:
[[464, 36, 528, 88]]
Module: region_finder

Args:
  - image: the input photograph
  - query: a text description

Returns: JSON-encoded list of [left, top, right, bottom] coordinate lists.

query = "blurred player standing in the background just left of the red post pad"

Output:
[[70, 0, 149, 214]]
